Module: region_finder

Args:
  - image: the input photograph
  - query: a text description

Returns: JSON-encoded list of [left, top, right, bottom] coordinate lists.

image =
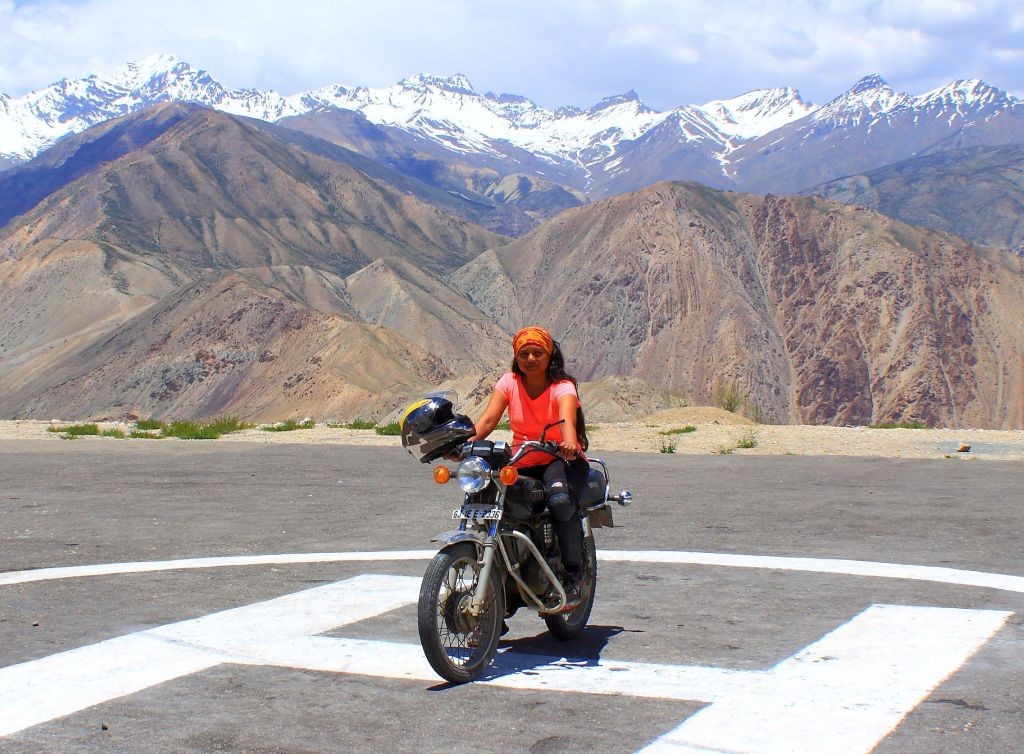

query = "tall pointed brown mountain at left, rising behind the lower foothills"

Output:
[[0, 106, 500, 274]]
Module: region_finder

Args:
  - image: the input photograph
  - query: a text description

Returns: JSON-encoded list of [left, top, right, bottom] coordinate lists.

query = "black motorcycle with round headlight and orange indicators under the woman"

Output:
[[407, 403, 633, 683]]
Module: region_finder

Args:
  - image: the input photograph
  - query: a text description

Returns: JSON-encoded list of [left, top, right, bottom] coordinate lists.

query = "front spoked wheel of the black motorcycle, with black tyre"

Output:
[[417, 542, 505, 683]]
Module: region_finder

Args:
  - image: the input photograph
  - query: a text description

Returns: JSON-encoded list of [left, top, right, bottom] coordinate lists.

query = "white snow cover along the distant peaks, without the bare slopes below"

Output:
[[0, 54, 1020, 175]]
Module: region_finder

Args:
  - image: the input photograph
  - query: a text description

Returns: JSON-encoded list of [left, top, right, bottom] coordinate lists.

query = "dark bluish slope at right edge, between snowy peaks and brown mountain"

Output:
[[804, 145, 1024, 253]]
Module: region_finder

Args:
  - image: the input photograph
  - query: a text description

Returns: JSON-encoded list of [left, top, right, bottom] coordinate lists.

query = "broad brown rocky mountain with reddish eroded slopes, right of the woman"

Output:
[[455, 183, 1024, 427]]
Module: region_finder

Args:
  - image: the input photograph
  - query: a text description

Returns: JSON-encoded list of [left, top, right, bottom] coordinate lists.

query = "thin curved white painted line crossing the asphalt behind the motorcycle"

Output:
[[0, 550, 1024, 593]]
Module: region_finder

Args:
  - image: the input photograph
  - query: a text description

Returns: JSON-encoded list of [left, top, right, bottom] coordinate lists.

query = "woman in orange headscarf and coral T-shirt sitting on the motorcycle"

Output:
[[471, 327, 590, 603]]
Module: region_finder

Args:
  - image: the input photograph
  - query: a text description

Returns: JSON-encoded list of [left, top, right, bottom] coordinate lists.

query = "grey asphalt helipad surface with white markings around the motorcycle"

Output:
[[0, 439, 1024, 754]]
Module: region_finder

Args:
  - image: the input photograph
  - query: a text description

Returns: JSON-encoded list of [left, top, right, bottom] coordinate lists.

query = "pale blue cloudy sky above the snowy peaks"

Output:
[[0, 0, 1024, 110]]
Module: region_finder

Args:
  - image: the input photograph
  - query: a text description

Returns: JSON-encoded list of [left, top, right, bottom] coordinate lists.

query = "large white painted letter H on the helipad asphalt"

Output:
[[0, 575, 1013, 754]]
